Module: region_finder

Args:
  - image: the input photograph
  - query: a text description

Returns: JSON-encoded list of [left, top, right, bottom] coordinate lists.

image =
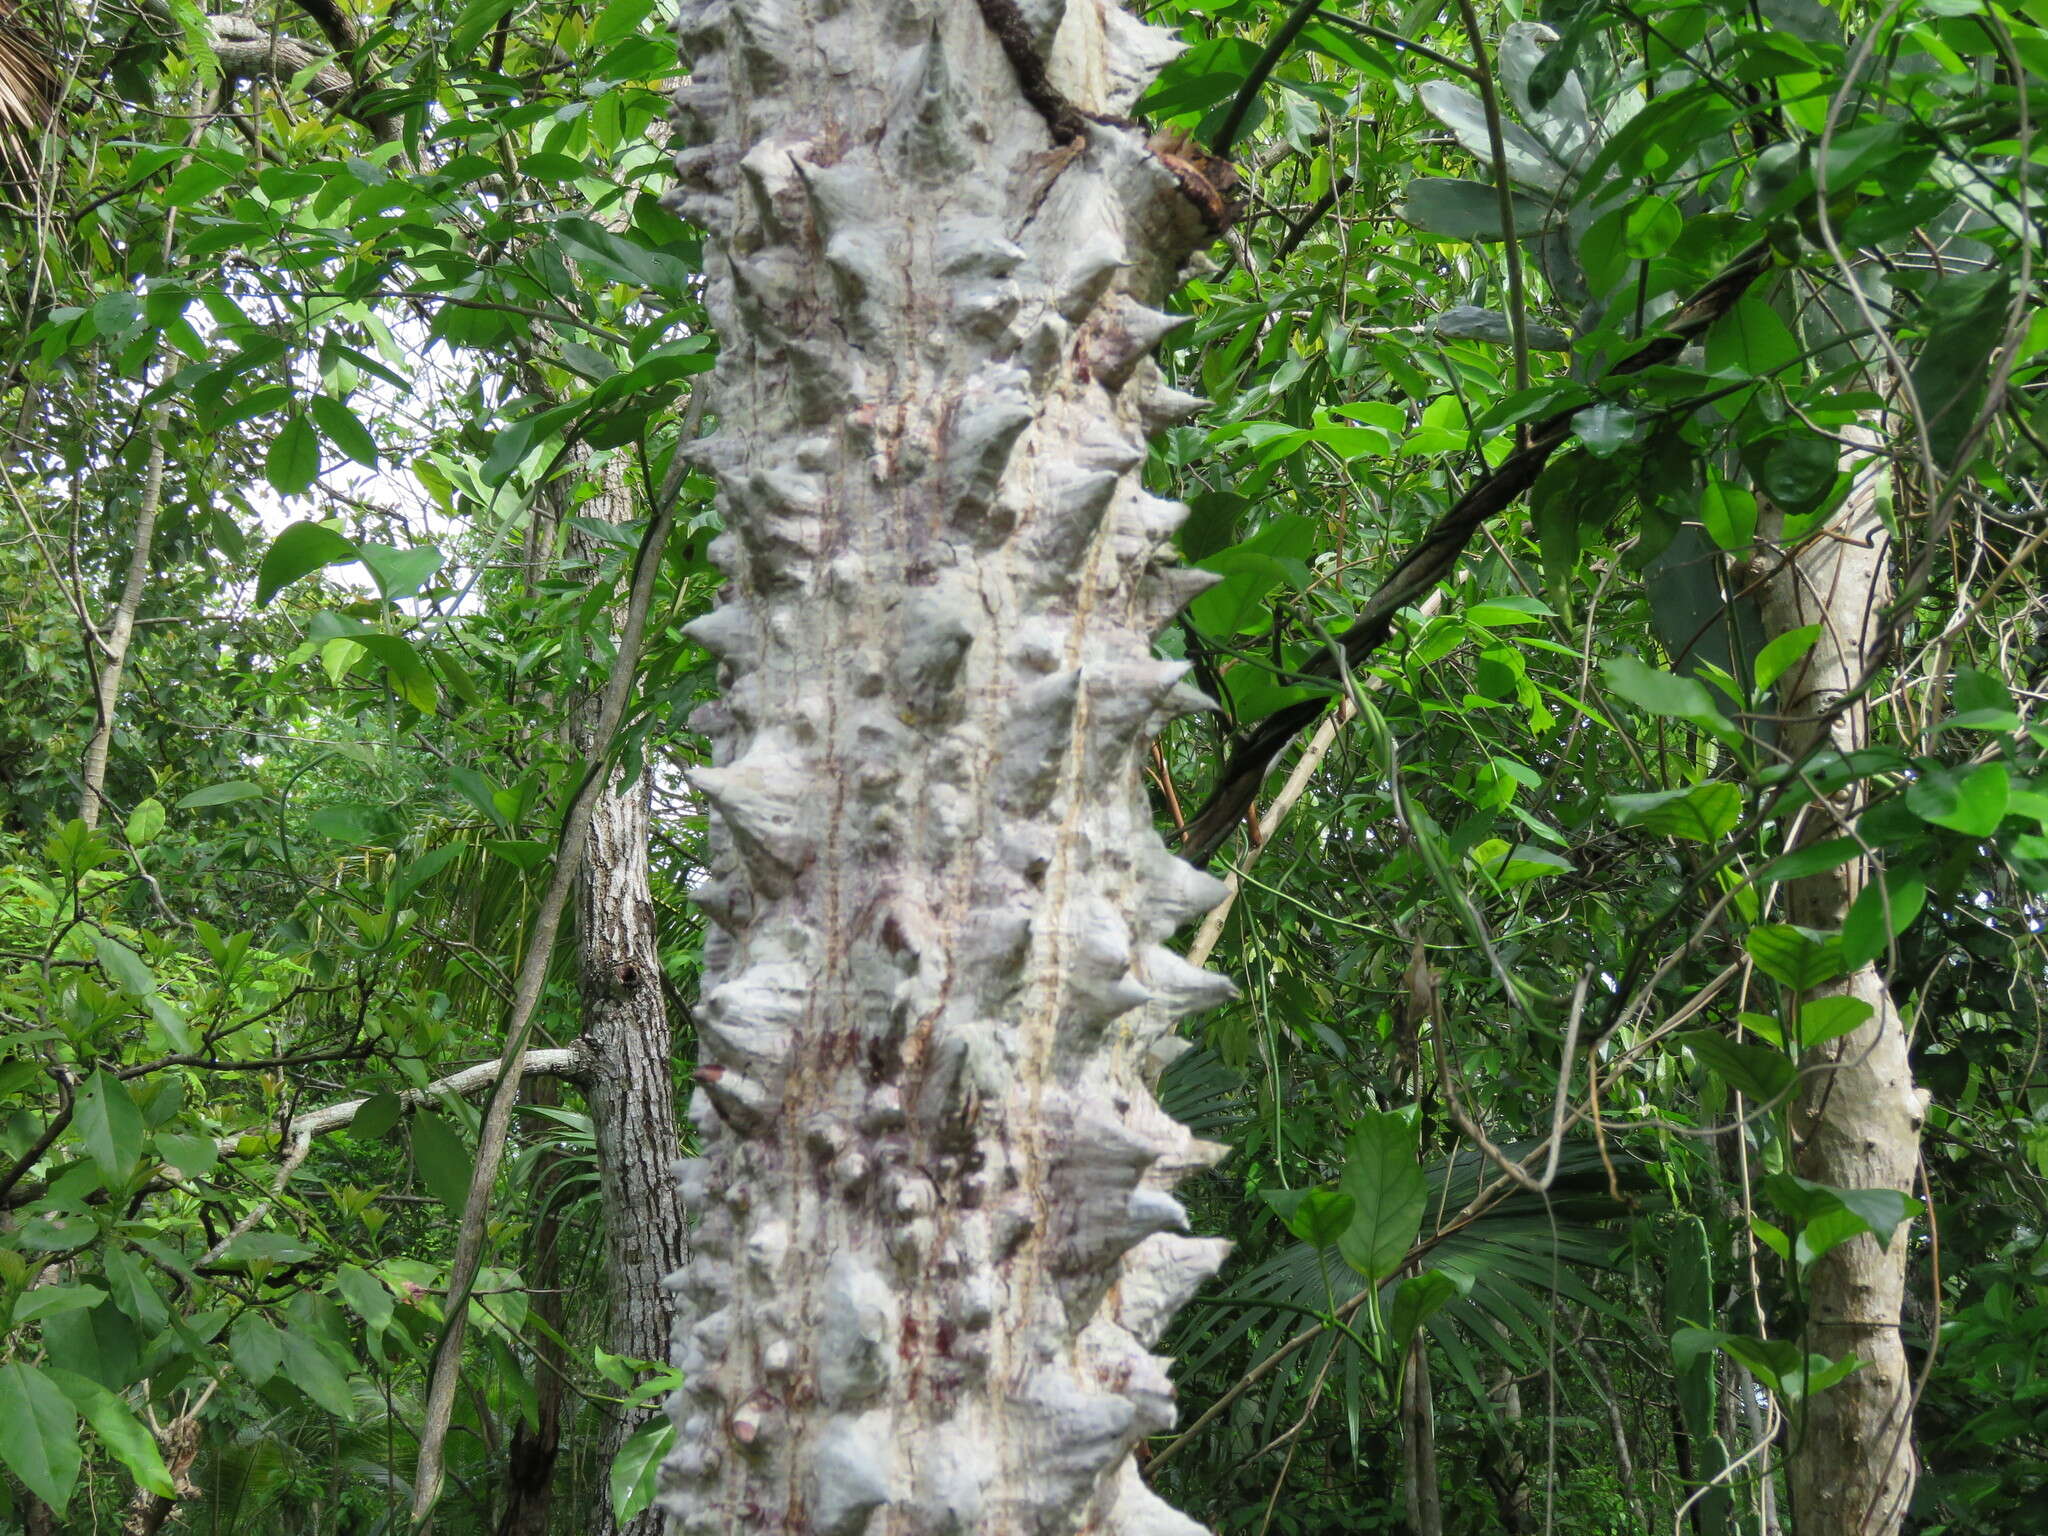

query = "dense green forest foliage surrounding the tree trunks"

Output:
[[0, 0, 2048, 1536]]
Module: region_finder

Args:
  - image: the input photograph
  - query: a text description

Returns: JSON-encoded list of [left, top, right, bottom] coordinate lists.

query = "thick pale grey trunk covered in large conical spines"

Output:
[[662, 0, 1229, 1536]]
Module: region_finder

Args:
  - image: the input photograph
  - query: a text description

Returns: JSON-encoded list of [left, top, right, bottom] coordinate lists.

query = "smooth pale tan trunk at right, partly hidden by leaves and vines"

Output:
[[1763, 438, 1923, 1536]]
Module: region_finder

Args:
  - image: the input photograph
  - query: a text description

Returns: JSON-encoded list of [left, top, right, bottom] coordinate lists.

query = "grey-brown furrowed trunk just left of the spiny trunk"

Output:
[[569, 483, 686, 1536]]
